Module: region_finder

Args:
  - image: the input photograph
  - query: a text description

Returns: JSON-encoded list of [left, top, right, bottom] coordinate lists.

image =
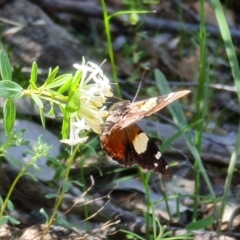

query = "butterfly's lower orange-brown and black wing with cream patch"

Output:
[[100, 124, 172, 179]]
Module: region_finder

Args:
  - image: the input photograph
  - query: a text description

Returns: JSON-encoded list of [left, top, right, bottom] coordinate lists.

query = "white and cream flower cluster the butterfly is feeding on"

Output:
[[61, 62, 113, 146]]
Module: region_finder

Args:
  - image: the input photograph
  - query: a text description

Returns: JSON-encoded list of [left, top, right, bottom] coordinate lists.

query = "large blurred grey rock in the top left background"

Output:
[[0, 0, 84, 69]]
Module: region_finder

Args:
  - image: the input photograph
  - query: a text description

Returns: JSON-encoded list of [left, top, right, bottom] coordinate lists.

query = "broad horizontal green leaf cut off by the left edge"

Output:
[[0, 80, 23, 100]]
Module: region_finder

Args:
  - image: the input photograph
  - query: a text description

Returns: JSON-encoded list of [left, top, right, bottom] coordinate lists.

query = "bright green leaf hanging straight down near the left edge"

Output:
[[3, 99, 16, 135]]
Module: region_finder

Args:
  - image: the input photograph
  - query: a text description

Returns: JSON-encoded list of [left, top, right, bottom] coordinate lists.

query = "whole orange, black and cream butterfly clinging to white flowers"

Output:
[[100, 90, 190, 179]]
